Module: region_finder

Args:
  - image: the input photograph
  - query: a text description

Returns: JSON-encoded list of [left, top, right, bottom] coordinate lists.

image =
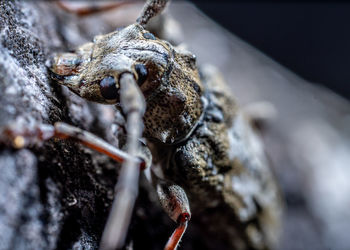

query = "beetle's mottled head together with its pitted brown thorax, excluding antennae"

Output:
[[50, 4, 203, 143]]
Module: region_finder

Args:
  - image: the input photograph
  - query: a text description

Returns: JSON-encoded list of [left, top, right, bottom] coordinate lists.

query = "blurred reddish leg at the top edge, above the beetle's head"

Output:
[[57, 0, 136, 16]]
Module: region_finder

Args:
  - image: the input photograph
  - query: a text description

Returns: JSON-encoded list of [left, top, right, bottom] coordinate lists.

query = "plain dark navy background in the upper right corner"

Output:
[[192, 0, 350, 99]]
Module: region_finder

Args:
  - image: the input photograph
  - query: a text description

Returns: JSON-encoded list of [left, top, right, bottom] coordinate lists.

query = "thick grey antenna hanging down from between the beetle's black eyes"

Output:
[[100, 73, 145, 250]]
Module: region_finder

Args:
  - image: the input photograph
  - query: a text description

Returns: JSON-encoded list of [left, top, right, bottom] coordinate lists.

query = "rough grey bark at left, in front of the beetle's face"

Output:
[[0, 1, 116, 249]]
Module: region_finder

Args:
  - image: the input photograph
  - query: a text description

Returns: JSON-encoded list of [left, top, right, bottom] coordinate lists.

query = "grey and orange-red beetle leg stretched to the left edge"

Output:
[[0, 122, 146, 169]]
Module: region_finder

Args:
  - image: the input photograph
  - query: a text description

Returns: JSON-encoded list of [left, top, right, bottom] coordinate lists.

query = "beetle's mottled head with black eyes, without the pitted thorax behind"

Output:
[[50, 24, 169, 104]]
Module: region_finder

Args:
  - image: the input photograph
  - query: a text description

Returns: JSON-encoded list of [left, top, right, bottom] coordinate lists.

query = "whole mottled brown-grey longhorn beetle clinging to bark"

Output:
[[4, 0, 281, 249]]
